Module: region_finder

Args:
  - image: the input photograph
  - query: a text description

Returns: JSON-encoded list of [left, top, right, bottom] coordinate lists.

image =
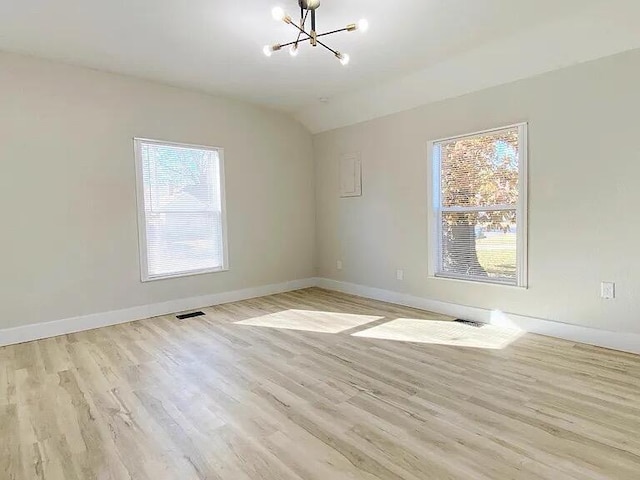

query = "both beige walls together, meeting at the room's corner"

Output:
[[5, 47, 640, 332]]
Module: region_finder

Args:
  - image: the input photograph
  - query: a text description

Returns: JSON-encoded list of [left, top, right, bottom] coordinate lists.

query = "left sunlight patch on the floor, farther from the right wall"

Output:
[[235, 310, 384, 333]]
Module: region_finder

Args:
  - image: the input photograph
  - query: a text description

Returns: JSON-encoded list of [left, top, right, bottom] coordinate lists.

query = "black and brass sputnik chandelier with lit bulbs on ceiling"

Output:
[[263, 0, 369, 65]]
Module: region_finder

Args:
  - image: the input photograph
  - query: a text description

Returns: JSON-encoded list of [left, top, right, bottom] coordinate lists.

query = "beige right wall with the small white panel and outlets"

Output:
[[314, 50, 640, 332]]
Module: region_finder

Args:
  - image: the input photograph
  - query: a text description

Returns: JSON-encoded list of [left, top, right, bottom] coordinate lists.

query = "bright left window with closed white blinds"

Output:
[[134, 138, 227, 281]]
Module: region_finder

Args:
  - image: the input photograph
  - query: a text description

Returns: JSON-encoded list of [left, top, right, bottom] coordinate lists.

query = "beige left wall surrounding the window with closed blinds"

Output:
[[0, 54, 314, 329]]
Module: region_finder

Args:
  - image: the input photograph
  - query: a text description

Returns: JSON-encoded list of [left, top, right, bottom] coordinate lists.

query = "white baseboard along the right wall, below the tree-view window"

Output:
[[315, 278, 640, 354]]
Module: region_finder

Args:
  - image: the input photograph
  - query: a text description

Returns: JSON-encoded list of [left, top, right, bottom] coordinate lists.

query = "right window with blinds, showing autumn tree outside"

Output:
[[430, 124, 527, 287]]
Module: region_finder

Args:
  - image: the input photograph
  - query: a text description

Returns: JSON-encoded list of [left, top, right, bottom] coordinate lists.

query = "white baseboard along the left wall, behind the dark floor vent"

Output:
[[0, 278, 316, 347]]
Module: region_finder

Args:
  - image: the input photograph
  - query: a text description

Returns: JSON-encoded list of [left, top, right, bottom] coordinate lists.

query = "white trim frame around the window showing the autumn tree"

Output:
[[427, 122, 529, 289]]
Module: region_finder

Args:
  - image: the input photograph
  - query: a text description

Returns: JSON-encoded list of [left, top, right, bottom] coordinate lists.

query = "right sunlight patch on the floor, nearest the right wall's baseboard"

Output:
[[352, 318, 525, 350]]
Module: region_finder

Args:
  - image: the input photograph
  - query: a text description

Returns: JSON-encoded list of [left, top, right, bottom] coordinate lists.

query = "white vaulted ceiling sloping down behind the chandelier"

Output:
[[0, 0, 640, 131]]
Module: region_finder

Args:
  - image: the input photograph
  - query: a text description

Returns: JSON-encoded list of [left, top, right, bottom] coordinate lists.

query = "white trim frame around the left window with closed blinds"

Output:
[[133, 137, 229, 282]]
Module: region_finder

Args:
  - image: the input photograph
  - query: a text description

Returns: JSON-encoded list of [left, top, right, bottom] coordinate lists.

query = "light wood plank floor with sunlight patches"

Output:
[[0, 289, 640, 480]]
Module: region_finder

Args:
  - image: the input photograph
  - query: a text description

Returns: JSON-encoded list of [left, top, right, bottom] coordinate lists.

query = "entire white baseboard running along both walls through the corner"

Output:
[[0, 278, 640, 354]]
